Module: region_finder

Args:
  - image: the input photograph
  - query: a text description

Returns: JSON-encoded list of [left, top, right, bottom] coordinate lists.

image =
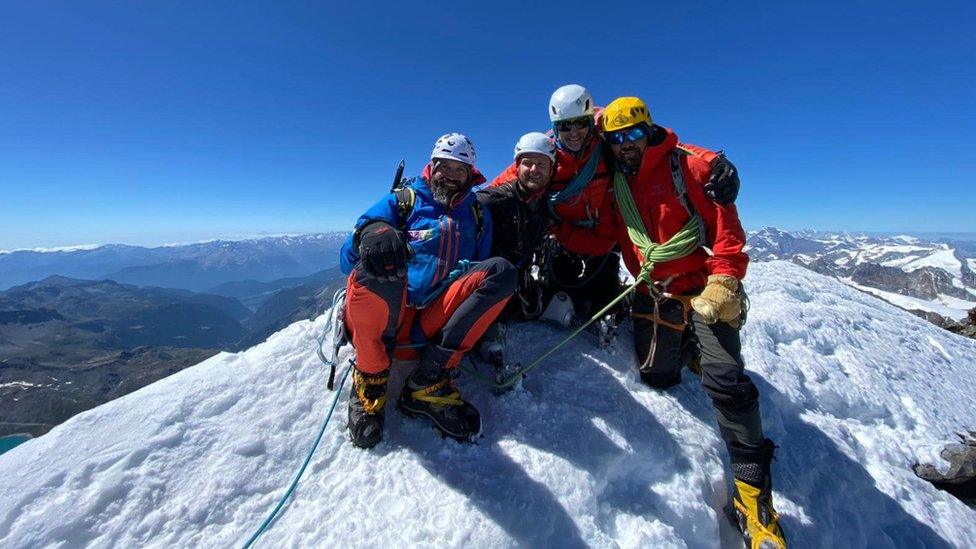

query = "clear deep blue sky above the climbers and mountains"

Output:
[[0, 1, 976, 249]]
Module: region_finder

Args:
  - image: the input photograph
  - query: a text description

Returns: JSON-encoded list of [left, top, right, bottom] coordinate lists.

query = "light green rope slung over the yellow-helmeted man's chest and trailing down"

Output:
[[465, 172, 701, 390]]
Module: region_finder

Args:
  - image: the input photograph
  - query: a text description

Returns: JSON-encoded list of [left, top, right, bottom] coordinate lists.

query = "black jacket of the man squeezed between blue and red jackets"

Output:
[[477, 181, 550, 269]]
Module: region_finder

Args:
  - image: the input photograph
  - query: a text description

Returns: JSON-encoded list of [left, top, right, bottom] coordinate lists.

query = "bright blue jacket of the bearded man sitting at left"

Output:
[[340, 176, 492, 306]]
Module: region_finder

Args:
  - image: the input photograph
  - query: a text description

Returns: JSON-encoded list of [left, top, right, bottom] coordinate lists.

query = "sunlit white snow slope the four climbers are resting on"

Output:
[[0, 262, 976, 548]]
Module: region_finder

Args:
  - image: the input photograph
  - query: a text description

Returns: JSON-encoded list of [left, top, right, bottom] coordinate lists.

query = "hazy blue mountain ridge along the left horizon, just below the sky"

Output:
[[0, 232, 347, 291]]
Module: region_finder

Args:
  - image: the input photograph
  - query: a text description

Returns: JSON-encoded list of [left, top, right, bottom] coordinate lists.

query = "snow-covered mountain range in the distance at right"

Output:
[[747, 228, 976, 320]]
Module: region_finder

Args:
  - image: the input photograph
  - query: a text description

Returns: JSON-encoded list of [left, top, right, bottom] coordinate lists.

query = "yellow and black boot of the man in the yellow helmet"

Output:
[[728, 438, 786, 549]]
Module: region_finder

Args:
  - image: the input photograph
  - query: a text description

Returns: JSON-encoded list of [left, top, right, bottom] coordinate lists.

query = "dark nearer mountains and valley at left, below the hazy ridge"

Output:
[[0, 267, 345, 436]]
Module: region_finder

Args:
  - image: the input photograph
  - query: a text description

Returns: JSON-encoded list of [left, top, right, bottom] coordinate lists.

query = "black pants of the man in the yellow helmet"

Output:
[[633, 292, 763, 446]]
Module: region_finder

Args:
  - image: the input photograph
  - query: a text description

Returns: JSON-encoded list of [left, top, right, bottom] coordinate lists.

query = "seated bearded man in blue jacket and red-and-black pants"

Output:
[[341, 133, 516, 448]]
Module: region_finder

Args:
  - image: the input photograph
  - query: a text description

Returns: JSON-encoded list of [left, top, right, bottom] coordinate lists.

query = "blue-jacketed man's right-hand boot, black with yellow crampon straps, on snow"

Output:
[[399, 345, 481, 442]]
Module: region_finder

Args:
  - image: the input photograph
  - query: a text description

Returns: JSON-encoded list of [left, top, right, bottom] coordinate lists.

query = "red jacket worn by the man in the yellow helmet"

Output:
[[611, 129, 749, 294]]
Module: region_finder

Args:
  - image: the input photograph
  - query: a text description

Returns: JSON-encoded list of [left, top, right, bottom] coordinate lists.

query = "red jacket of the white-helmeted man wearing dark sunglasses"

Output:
[[490, 136, 617, 255]]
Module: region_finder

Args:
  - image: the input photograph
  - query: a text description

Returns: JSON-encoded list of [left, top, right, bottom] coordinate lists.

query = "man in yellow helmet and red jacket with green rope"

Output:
[[602, 97, 785, 547]]
